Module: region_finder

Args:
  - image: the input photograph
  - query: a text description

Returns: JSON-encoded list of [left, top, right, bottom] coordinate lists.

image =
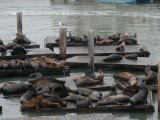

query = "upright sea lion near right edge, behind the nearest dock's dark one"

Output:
[[144, 65, 157, 85]]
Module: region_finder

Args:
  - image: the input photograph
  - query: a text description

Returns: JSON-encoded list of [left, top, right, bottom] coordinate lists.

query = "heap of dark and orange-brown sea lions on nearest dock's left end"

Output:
[[20, 73, 68, 110]]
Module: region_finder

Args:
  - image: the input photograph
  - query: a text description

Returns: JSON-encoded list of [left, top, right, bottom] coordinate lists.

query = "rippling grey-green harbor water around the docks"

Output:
[[0, 0, 160, 120]]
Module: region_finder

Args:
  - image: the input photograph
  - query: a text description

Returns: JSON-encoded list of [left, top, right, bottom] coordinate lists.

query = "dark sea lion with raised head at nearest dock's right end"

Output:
[[129, 85, 148, 105]]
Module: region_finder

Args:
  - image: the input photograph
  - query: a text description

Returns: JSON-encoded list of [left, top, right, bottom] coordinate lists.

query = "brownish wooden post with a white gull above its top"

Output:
[[59, 27, 67, 59]]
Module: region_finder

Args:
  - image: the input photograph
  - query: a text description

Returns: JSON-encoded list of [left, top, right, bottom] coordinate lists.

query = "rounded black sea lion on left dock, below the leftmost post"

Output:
[[11, 45, 27, 55]]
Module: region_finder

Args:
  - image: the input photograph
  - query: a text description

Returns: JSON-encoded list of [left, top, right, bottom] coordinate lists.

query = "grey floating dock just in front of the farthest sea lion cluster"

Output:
[[54, 45, 150, 57]]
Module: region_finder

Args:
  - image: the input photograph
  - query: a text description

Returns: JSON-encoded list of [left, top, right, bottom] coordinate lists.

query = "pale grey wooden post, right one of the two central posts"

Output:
[[88, 30, 94, 72]]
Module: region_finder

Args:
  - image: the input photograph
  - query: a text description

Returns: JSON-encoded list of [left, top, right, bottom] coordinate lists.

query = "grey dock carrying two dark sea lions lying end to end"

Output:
[[66, 56, 158, 70]]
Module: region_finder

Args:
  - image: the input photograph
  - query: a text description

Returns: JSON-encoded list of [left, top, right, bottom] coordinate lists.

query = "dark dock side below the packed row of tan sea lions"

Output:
[[0, 66, 70, 77]]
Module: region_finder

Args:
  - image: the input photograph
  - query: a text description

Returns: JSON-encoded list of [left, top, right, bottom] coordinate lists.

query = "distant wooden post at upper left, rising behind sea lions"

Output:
[[17, 12, 22, 34]]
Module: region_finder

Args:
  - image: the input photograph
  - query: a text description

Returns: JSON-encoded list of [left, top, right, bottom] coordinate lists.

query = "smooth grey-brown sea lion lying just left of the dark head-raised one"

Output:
[[97, 95, 130, 106]]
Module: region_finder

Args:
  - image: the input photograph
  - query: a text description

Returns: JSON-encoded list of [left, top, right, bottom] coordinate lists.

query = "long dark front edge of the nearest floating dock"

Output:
[[22, 104, 154, 113]]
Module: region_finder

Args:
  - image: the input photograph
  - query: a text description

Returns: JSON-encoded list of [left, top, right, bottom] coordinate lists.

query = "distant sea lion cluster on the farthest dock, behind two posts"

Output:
[[56, 32, 137, 45]]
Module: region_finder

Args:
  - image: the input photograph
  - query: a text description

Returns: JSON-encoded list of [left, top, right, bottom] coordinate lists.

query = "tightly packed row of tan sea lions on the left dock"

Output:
[[0, 56, 65, 70]]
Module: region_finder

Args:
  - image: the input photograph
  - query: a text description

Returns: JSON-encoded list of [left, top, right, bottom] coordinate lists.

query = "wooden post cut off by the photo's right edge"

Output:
[[157, 61, 160, 112]]
